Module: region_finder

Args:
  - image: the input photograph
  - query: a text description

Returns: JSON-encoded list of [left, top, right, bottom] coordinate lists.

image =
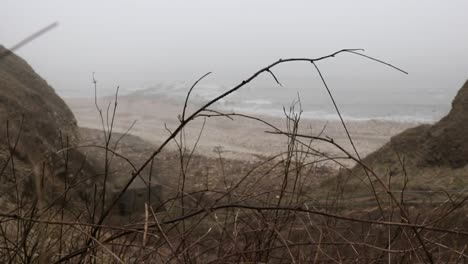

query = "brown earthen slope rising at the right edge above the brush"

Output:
[[323, 81, 468, 192]]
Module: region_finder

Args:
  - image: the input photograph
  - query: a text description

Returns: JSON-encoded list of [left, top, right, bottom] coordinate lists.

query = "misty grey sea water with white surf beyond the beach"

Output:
[[124, 82, 451, 123]]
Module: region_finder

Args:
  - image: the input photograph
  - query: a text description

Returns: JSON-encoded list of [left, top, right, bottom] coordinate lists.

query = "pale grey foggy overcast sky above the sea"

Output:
[[0, 0, 468, 101]]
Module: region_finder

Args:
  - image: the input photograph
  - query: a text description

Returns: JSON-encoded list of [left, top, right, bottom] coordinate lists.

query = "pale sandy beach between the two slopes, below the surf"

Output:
[[65, 96, 417, 168]]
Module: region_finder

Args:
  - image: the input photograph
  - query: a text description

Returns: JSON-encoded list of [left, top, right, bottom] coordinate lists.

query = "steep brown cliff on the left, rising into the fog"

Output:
[[0, 46, 92, 206]]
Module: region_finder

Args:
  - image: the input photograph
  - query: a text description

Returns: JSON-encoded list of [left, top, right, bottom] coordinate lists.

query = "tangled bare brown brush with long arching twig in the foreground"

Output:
[[0, 46, 468, 263]]
